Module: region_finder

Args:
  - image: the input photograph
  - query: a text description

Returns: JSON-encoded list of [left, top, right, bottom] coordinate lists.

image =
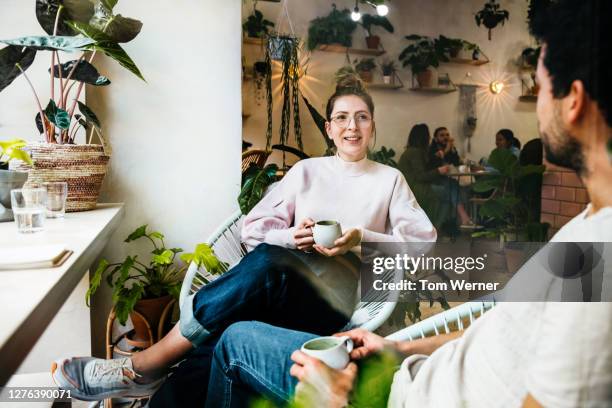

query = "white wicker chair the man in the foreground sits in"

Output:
[[387, 301, 495, 341]]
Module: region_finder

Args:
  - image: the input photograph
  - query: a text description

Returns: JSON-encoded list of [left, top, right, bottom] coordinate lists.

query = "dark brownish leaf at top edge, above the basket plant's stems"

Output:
[[36, 0, 94, 36]]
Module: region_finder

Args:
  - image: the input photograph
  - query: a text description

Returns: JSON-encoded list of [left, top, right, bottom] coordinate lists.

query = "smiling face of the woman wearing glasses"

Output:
[[325, 95, 374, 161]]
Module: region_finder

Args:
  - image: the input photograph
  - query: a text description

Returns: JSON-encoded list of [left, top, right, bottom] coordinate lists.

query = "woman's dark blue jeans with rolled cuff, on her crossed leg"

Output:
[[180, 244, 359, 347]]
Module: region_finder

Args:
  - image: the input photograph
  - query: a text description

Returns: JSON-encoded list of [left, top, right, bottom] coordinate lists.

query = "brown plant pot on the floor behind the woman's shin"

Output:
[[130, 295, 174, 347]]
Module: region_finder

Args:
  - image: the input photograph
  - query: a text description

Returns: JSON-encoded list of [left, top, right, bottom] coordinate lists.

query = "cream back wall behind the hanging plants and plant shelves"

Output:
[[242, 0, 537, 166]]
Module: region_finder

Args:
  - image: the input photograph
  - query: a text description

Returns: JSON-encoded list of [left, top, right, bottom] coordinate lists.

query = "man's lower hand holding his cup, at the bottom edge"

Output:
[[289, 350, 357, 408]]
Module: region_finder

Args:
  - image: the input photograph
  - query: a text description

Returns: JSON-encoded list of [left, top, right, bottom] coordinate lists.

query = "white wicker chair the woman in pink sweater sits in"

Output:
[[179, 211, 402, 331]]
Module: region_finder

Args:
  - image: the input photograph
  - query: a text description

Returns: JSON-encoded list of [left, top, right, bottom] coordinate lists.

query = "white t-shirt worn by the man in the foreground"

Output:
[[388, 207, 612, 408]]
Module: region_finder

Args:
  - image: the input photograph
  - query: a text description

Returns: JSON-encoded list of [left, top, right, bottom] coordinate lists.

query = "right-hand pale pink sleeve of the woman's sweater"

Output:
[[361, 173, 437, 242]]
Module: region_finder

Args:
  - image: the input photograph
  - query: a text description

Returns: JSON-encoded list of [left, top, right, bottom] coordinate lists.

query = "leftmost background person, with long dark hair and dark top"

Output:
[[398, 123, 473, 226]]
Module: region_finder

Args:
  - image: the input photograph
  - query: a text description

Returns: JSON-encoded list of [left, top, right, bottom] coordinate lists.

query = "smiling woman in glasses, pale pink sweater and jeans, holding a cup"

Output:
[[52, 78, 436, 406]]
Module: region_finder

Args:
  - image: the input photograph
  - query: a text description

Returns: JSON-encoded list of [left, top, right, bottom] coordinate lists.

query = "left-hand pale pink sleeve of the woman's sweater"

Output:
[[242, 165, 300, 251]]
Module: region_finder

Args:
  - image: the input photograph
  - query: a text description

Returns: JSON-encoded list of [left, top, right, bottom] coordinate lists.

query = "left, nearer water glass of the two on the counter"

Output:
[[11, 188, 47, 233]]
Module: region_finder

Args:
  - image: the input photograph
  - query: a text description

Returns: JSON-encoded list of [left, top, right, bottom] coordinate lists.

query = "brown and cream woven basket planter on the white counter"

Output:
[[11, 143, 110, 212]]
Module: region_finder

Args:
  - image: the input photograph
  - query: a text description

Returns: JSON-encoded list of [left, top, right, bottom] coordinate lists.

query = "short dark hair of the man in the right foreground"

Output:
[[529, 0, 612, 126]]
